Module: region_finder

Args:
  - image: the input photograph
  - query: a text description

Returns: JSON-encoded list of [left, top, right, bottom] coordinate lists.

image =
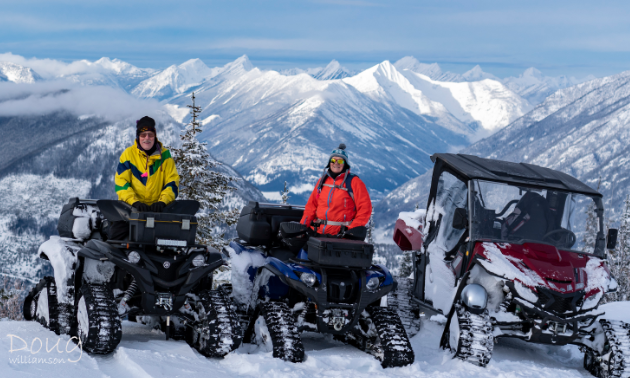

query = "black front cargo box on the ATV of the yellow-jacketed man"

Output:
[[129, 212, 197, 246]]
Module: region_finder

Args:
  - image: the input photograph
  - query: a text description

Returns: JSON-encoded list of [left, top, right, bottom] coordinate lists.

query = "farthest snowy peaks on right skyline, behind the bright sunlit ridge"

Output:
[[394, 56, 595, 105]]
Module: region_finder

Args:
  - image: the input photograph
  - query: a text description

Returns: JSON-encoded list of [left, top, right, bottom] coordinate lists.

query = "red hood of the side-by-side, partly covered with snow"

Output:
[[474, 242, 610, 298]]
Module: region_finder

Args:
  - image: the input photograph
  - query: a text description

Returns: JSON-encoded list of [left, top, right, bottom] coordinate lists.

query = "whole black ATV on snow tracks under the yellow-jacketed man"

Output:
[[24, 198, 242, 357]]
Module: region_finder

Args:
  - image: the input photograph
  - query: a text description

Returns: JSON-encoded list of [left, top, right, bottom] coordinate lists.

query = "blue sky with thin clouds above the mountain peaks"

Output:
[[0, 0, 630, 77]]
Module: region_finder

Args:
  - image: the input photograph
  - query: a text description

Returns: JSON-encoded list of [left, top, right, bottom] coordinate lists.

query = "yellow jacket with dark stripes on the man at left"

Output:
[[114, 138, 179, 205]]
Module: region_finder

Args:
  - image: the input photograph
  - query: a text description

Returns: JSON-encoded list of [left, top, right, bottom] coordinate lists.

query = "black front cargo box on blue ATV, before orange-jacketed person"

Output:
[[307, 238, 374, 268]]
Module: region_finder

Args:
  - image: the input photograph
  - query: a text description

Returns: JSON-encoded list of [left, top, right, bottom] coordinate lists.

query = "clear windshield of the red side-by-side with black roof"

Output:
[[469, 180, 604, 253]]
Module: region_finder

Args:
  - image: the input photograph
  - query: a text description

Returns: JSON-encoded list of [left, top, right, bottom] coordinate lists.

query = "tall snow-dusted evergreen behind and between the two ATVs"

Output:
[[171, 92, 239, 249]]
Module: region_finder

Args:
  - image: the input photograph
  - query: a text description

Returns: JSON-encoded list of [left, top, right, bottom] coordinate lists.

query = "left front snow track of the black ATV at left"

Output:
[[76, 283, 122, 354]]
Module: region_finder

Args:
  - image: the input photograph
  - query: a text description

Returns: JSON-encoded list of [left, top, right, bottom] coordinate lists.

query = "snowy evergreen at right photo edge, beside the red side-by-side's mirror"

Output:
[[606, 196, 630, 302]]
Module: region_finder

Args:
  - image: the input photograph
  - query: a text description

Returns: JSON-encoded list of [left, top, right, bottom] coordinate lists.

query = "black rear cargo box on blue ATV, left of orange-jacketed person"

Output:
[[236, 201, 304, 246]]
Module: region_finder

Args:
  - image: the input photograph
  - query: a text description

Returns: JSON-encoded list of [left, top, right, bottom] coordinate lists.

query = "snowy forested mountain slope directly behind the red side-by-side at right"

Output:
[[375, 71, 630, 241]]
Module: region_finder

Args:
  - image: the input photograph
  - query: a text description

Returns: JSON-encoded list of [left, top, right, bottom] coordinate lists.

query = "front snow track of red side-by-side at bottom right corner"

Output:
[[584, 319, 630, 378]]
